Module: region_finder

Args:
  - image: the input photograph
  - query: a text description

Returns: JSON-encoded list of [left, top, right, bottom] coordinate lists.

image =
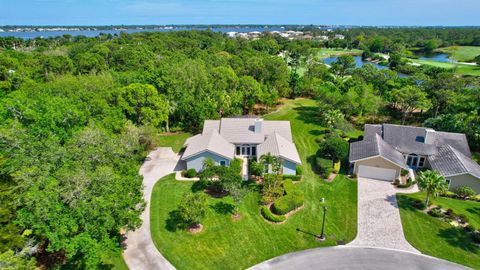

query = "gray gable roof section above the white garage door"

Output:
[[349, 134, 407, 168]]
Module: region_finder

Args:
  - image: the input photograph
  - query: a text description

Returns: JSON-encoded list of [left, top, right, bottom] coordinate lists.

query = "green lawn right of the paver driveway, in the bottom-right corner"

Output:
[[397, 193, 480, 269]]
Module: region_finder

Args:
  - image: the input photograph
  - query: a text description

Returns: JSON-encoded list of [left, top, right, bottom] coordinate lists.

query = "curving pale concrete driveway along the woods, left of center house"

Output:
[[123, 147, 180, 270]]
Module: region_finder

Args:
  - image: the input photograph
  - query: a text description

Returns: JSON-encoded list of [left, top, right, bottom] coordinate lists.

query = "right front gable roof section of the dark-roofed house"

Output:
[[428, 144, 480, 178]]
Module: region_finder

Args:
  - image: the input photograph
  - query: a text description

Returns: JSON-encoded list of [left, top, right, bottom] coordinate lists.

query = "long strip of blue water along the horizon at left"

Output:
[[0, 26, 285, 39]]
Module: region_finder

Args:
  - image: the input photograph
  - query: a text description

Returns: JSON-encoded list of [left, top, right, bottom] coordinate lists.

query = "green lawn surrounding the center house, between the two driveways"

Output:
[[151, 99, 357, 269]]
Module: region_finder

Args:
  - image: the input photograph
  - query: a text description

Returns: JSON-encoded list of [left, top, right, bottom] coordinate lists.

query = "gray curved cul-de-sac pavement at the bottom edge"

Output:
[[250, 246, 469, 270]]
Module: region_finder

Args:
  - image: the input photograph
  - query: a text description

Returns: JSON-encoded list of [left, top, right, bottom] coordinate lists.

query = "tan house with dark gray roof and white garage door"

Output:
[[349, 124, 480, 193]]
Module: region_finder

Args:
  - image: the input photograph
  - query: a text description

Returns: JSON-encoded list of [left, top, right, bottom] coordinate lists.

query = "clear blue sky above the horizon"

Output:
[[0, 0, 480, 25]]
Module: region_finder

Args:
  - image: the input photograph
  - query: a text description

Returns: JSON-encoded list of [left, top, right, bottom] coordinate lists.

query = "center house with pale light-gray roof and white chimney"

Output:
[[182, 117, 301, 175]]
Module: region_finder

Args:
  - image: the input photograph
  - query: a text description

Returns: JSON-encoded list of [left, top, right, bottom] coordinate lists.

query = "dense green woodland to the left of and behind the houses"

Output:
[[0, 29, 480, 268]]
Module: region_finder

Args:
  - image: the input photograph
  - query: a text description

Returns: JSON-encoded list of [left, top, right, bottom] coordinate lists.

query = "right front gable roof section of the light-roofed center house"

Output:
[[257, 132, 302, 164]]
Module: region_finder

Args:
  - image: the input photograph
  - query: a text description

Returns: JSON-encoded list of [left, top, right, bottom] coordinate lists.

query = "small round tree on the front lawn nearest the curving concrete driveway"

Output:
[[178, 192, 207, 226]]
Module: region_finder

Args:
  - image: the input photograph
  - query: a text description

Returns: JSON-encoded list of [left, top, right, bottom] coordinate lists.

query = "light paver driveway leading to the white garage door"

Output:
[[348, 177, 420, 254]]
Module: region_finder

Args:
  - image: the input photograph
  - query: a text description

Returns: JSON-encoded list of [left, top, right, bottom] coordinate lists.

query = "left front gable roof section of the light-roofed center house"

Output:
[[182, 130, 235, 160]]
